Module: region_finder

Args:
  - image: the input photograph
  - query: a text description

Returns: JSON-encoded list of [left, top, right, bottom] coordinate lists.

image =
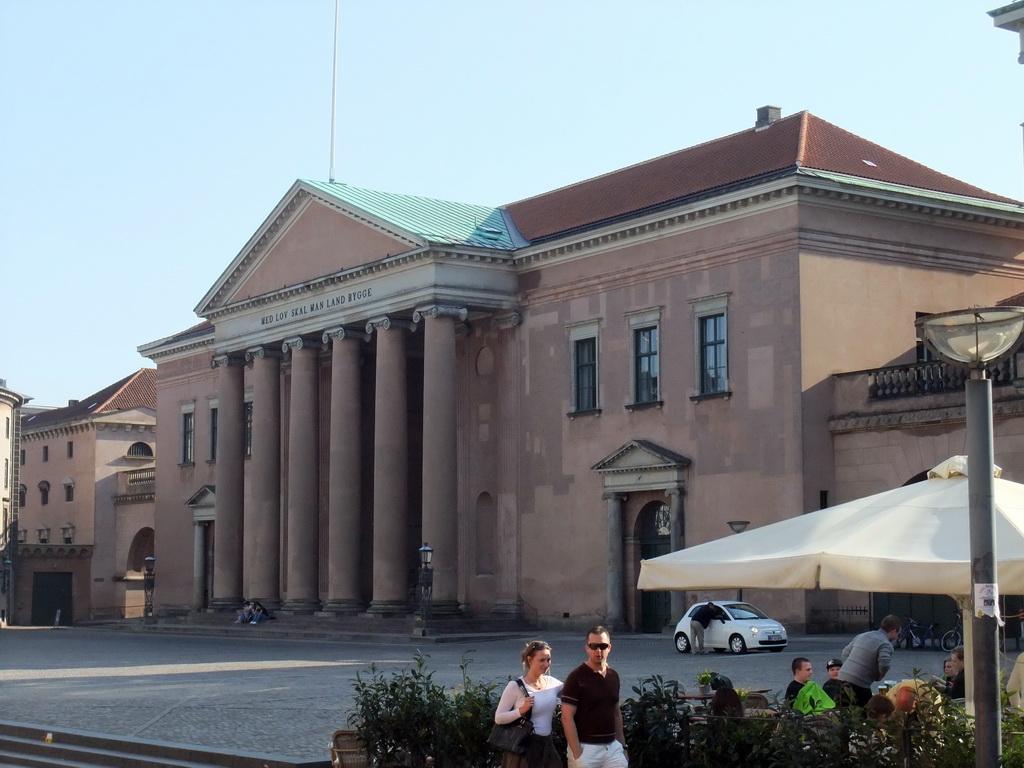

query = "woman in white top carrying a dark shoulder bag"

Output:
[[495, 640, 562, 768]]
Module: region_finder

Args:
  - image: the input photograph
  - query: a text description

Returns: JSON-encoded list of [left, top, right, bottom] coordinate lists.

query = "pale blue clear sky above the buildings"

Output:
[[0, 0, 1024, 406]]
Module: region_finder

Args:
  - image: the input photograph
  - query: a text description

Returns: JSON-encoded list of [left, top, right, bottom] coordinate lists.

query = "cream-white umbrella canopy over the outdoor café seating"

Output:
[[637, 457, 1024, 595]]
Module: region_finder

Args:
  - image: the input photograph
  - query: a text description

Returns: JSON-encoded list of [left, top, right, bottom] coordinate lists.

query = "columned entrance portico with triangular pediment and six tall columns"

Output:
[[174, 182, 517, 616]]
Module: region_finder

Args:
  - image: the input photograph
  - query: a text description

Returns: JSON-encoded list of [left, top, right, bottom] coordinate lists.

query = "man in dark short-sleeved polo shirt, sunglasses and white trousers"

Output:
[[562, 627, 629, 768]]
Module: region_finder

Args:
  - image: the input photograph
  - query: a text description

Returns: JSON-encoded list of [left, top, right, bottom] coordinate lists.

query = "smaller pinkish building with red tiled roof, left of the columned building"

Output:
[[13, 368, 157, 625]]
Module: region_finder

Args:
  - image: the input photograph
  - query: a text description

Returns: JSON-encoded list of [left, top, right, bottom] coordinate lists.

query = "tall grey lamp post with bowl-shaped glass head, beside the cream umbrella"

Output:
[[915, 307, 1024, 768]]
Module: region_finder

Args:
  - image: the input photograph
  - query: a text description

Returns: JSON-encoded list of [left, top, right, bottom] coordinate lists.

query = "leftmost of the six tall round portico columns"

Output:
[[210, 354, 245, 610]]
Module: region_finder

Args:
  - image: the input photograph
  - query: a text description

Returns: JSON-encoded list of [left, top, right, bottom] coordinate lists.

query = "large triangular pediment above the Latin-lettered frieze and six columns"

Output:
[[196, 181, 426, 316]]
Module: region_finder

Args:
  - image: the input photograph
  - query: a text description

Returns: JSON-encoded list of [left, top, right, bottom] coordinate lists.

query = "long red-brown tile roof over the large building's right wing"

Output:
[[506, 112, 1016, 241]]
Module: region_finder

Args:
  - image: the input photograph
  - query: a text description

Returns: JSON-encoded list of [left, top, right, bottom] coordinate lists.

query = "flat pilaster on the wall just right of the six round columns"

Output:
[[492, 312, 523, 617]]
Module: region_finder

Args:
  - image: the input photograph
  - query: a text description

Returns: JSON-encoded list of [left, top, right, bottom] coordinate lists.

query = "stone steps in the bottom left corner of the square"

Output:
[[0, 721, 331, 768]]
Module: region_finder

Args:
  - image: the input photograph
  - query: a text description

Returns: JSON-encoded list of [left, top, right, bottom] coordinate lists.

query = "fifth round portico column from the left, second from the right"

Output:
[[367, 317, 411, 615]]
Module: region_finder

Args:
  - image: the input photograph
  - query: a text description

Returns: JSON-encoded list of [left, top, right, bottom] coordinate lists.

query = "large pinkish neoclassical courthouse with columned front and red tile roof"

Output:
[[140, 106, 1024, 631]]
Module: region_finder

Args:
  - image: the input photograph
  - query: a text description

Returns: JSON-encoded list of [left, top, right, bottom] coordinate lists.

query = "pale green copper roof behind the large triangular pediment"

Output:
[[300, 179, 523, 251]]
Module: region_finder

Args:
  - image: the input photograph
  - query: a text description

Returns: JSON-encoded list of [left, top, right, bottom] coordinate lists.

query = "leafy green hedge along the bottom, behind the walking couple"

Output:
[[348, 654, 1024, 768]]
